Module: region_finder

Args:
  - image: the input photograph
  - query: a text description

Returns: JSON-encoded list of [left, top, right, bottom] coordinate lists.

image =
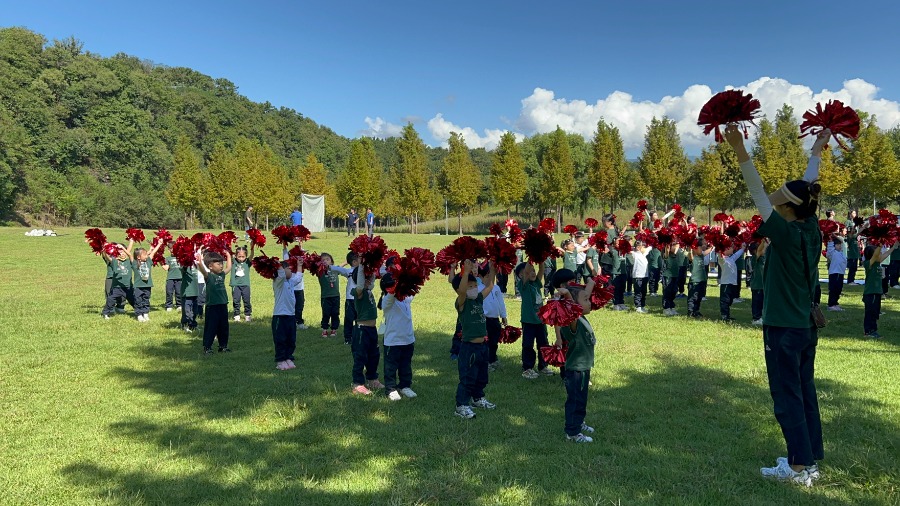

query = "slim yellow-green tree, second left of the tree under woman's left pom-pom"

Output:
[[587, 119, 628, 212]]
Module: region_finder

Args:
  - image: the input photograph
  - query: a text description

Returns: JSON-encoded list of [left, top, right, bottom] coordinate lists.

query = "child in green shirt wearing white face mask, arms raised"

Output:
[[453, 260, 496, 419]]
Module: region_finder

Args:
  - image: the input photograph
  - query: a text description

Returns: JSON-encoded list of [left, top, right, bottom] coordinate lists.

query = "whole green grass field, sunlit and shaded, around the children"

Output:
[[0, 229, 900, 506]]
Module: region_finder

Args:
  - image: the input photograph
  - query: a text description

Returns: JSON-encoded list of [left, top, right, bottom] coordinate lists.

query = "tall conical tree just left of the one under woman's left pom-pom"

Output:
[[639, 117, 689, 203]]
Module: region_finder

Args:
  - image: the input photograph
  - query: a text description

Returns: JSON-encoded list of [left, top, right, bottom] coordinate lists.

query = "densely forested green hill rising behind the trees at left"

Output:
[[0, 28, 350, 226]]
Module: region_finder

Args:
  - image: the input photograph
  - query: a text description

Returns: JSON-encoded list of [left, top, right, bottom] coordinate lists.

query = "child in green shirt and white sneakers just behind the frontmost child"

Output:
[[516, 262, 552, 379]]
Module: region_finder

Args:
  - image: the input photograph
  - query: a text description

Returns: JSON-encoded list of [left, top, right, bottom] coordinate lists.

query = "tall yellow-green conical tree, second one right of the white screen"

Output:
[[398, 123, 431, 234]]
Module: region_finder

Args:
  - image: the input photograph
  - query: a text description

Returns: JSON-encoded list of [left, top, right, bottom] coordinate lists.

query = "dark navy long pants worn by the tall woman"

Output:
[[763, 325, 825, 466]]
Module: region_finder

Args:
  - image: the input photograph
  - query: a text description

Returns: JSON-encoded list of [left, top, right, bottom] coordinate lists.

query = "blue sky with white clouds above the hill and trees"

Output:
[[7, 0, 900, 152]]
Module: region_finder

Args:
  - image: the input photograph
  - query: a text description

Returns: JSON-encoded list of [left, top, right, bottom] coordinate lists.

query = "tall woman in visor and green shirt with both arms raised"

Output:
[[725, 125, 831, 486]]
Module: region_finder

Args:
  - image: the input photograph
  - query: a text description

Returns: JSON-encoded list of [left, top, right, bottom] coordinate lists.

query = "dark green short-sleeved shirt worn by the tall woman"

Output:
[[758, 212, 822, 328]]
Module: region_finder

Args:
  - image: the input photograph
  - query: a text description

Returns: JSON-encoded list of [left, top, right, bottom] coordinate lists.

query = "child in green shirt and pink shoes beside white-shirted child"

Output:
[[350, 265, 384, 395]]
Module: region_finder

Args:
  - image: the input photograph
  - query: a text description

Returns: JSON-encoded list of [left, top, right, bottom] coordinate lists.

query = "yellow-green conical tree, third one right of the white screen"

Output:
[[439, 132, 481, 235]]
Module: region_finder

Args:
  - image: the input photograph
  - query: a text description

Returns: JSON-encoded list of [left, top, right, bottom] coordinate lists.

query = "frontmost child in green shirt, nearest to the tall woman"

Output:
[[555, 271, 596, 443]]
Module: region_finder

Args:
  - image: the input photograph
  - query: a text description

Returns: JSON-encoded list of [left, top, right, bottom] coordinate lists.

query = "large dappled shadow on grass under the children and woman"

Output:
[[63, 321, 900, 505]]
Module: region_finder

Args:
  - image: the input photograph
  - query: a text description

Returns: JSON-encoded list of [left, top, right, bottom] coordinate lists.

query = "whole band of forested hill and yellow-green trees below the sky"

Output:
[[0, 28, 900, 232]]
